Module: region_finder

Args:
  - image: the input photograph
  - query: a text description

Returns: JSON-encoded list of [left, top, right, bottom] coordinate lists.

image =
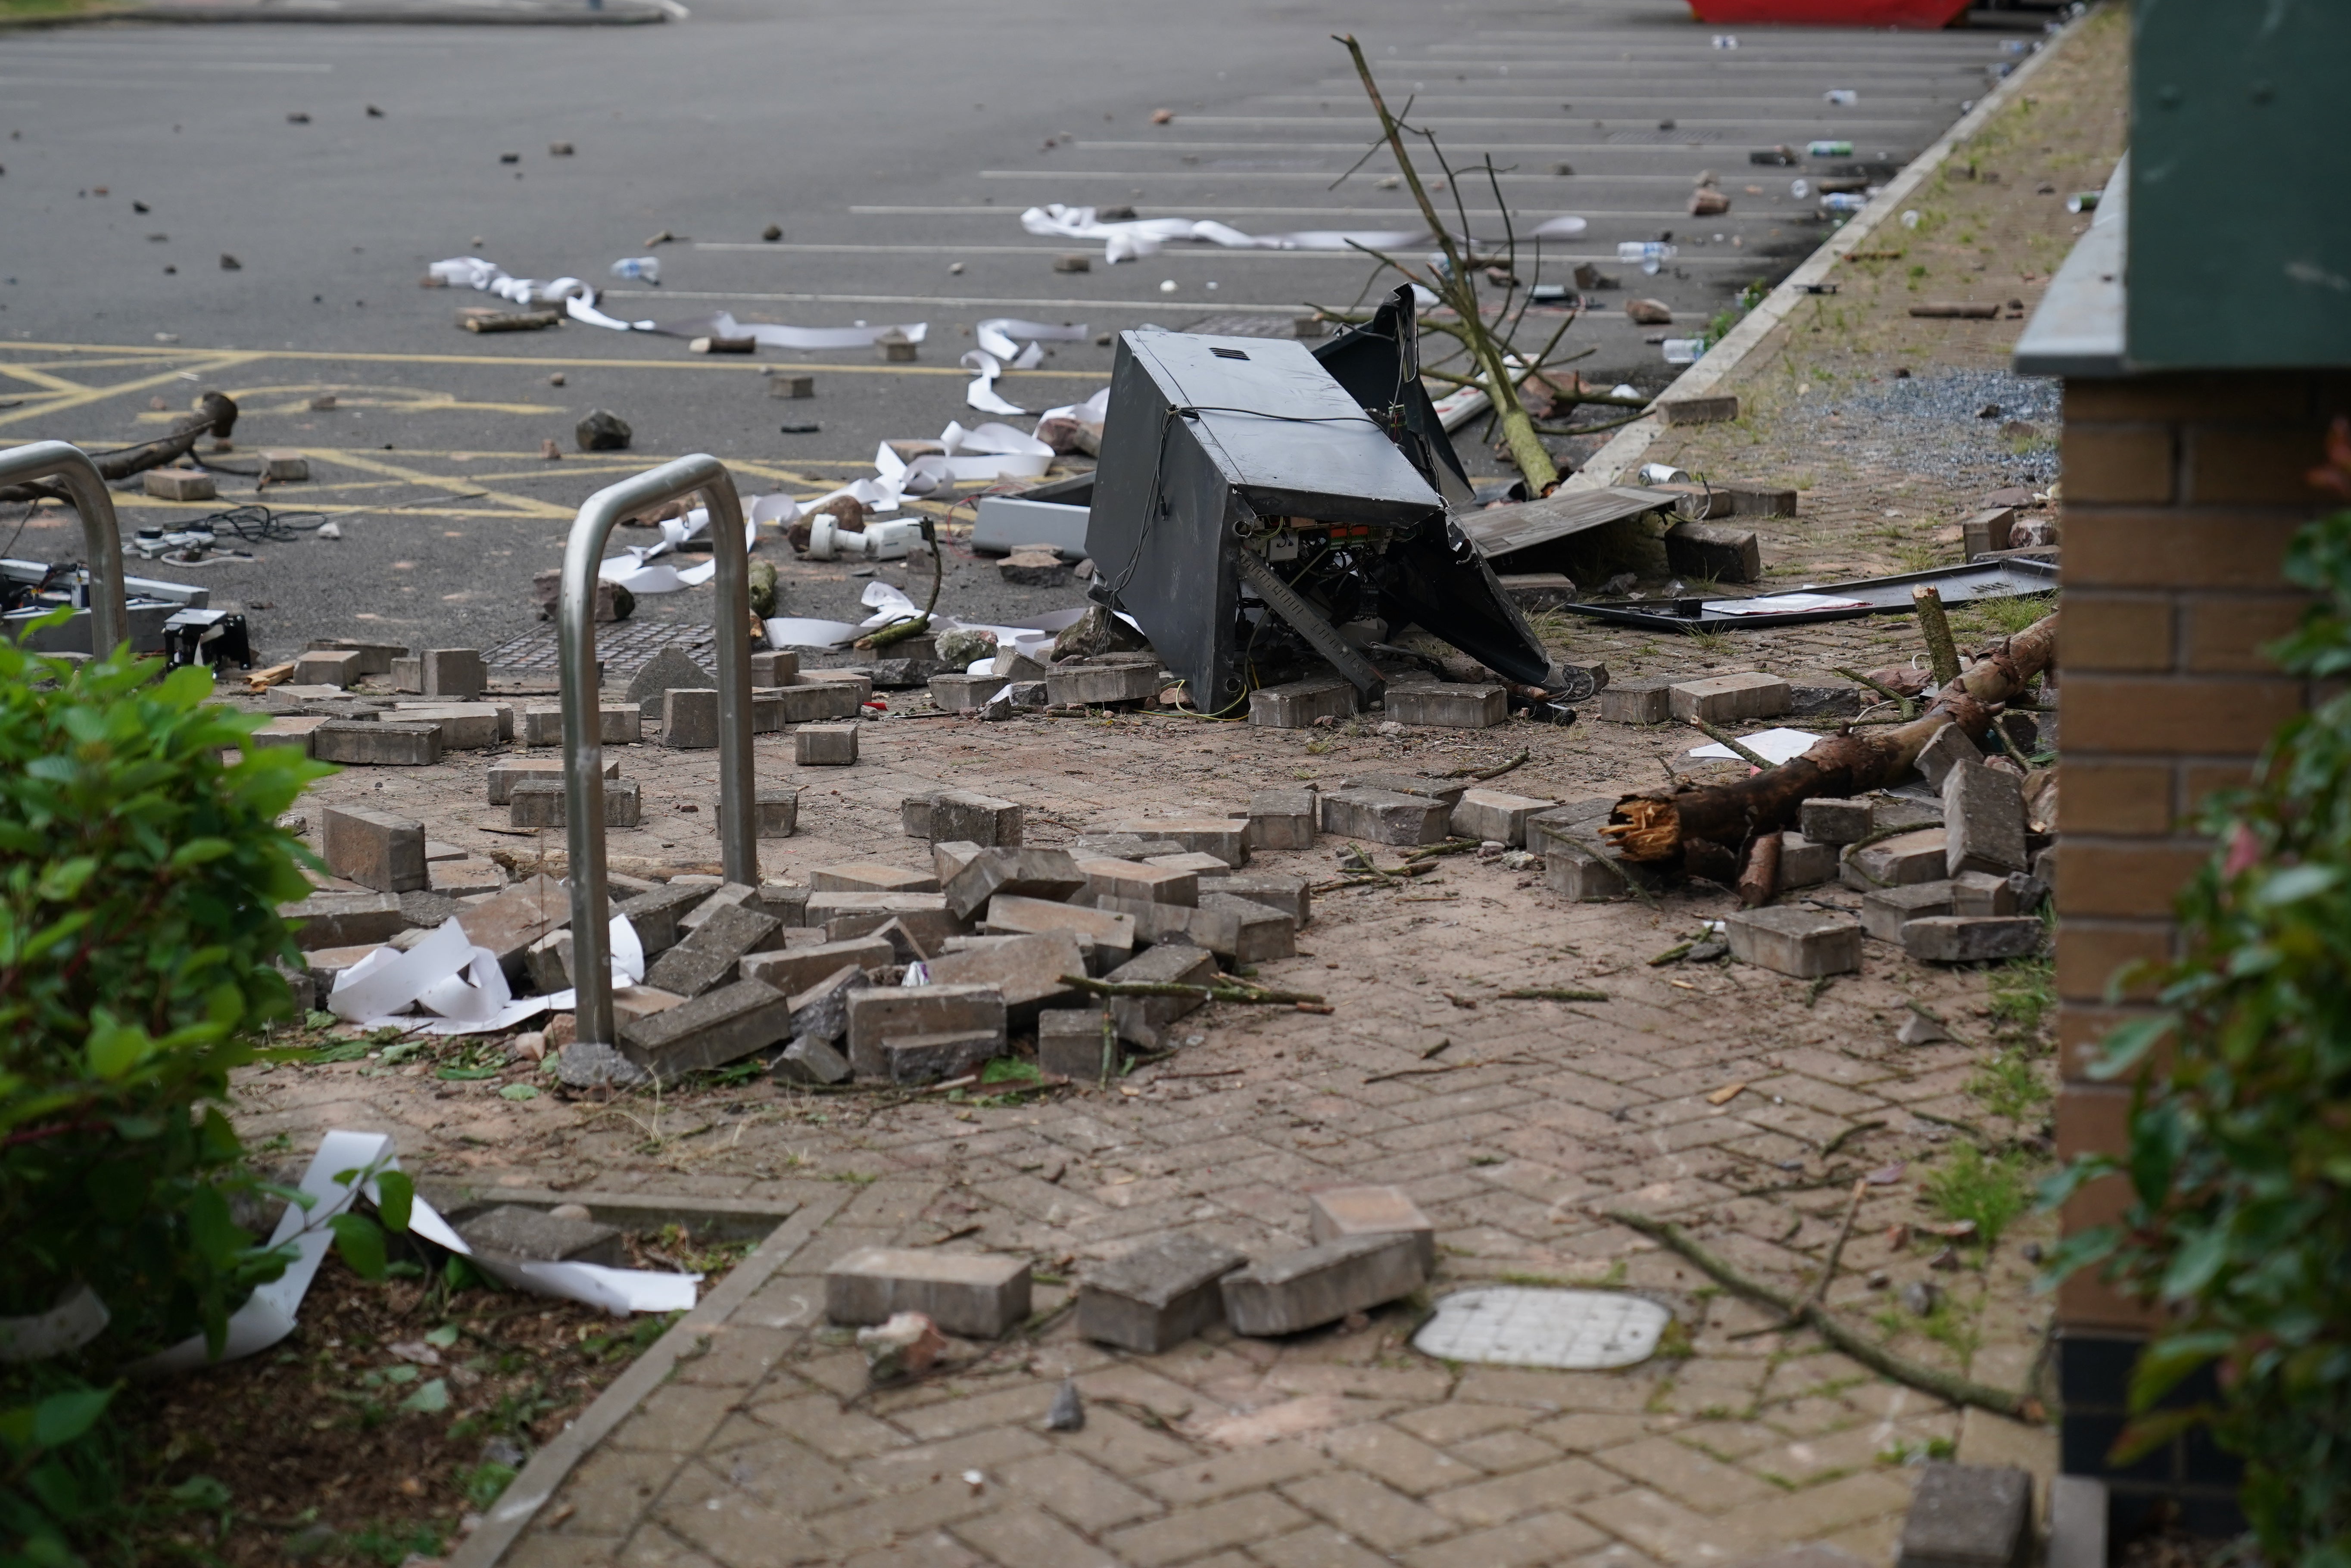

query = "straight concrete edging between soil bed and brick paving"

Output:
[[449, 1189, 849, 1568]]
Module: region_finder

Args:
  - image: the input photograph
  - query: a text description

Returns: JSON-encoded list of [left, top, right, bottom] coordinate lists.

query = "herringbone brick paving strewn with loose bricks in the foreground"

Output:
[[237, 696, 2045, 1568]]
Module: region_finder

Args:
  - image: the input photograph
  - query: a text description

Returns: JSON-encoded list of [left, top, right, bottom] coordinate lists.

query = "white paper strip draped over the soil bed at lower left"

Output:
[[129, 1128, 701, 1378]]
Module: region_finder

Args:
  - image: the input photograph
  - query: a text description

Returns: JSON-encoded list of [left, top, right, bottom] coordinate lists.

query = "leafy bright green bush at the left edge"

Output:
[[0, 644, 327, 1349]]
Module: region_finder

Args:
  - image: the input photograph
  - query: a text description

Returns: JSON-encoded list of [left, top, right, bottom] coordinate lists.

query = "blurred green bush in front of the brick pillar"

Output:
[[2045, 426, 2351, 1568]]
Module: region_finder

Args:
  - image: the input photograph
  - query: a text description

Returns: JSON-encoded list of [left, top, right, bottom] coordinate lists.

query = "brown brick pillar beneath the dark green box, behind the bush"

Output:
[[2057, 371, 2351, 1528]]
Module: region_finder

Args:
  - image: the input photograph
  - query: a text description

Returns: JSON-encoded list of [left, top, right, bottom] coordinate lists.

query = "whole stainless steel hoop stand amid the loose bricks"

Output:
[[557, 454, 759, 1044]]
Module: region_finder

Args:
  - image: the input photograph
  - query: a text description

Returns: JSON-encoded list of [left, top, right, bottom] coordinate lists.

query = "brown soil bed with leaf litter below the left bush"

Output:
[[118, 1227, 750, 1568]]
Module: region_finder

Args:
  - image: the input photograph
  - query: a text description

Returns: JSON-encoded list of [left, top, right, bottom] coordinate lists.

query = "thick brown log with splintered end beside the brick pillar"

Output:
[[1601, 616, 2057, 865]]
